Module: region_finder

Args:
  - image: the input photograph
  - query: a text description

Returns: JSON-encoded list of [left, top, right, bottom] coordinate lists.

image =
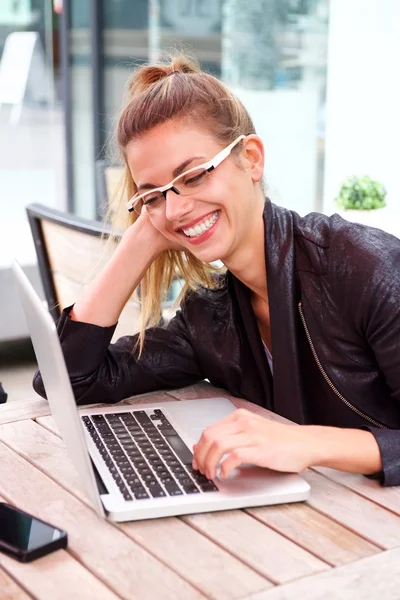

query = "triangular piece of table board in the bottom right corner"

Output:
[[246, 548, 400, 600]]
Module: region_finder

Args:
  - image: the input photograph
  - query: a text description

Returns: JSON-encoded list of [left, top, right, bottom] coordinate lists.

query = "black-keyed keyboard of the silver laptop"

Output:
[[81, 409, 218, 500]]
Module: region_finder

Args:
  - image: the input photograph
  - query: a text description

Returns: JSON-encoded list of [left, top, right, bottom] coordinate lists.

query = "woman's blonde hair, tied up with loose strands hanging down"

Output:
[[109, 54, 255, 356]]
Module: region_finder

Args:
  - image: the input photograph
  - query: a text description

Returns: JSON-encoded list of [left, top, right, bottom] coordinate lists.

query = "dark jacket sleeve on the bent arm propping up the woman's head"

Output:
[[33, 306, 204, 404]]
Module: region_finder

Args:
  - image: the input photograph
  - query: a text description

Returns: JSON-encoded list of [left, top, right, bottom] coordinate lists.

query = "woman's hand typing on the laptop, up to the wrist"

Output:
[[193, 408, 315, 479]]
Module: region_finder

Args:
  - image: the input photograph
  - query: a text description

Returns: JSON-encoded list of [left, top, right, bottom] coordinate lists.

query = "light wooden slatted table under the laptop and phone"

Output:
[[0, 383, 400, 600]]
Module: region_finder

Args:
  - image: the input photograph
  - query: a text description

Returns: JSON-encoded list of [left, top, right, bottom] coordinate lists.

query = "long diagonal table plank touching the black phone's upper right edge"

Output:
[[0, 443, 204, 600]]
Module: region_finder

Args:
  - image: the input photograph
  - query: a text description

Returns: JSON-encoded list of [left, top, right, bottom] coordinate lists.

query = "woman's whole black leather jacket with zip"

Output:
[[34, 200, 400, 485]]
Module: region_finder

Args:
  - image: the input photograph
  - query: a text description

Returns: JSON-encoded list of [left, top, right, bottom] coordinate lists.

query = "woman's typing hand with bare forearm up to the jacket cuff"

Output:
[[193, 408, 382, 479]]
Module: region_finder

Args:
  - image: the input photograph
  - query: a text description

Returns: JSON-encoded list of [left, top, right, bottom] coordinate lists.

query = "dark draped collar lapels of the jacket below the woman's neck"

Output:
[[232, 199, 304, 423]]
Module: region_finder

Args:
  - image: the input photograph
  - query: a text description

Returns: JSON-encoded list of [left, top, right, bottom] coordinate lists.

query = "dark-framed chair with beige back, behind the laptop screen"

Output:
[[26, 204, 140, 339]]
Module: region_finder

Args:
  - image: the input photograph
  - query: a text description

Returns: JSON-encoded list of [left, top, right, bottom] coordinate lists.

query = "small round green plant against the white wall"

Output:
[[335, 175, 386, 210]]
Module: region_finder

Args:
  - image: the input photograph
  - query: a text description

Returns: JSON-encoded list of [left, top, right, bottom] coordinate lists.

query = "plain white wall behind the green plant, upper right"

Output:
[[323, 0, 400, 235]]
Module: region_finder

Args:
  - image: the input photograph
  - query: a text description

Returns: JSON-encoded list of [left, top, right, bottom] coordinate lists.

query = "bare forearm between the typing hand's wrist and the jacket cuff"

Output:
[[310, 426, 382, 475]]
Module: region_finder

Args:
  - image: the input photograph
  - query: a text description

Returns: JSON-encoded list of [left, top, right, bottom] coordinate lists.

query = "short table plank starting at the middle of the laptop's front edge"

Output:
[[182, 510, 330, 584]]
